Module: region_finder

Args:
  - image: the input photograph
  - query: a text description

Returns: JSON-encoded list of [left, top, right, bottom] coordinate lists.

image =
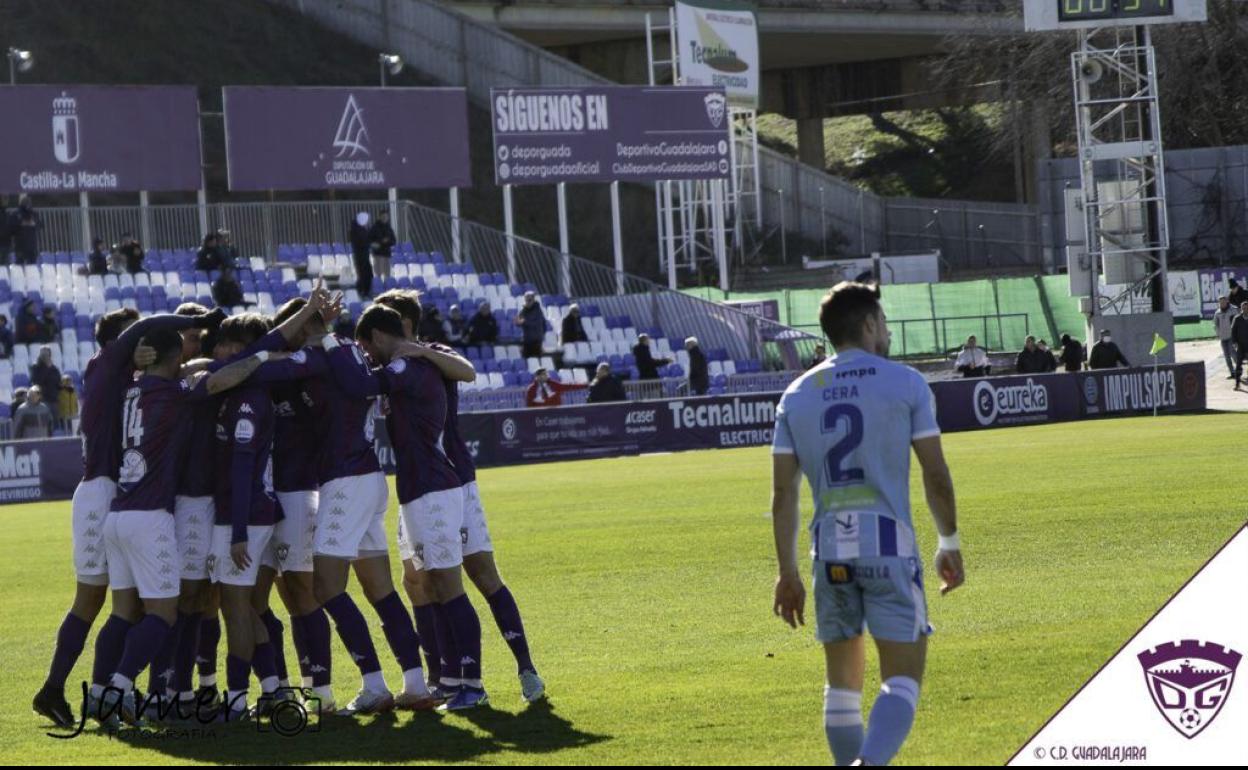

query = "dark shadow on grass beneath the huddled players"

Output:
[[59, 701, 610, 765]]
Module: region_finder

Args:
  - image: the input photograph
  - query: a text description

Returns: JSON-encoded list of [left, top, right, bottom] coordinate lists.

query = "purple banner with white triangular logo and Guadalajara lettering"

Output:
[[222, 86, 472, 190]]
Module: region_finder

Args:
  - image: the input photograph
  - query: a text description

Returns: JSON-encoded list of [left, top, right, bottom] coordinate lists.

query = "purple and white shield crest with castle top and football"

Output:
[[1137, 639, 1242, 738]]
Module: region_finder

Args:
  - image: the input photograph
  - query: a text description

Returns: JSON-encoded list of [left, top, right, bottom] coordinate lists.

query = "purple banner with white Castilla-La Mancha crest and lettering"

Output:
[[0, 85, 203, 193]]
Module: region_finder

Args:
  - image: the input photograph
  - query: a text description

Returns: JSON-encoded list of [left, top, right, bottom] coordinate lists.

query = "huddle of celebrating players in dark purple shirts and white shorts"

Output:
[[34, 285, 544, 726]]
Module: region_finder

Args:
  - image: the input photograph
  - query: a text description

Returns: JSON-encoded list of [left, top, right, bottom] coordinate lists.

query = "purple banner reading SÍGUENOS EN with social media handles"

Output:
[[490, 86, 731, 185]]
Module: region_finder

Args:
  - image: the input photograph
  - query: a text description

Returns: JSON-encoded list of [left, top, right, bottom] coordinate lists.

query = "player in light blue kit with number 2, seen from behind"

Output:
[[771, 282, 965, 765]]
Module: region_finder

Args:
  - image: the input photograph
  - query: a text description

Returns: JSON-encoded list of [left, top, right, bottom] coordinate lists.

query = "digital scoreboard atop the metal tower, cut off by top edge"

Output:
[[1023, 0, 1208, 32]]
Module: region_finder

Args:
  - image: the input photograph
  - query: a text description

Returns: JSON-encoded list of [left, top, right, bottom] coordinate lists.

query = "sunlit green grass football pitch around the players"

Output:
[[0, 414, 1248, 765]]
